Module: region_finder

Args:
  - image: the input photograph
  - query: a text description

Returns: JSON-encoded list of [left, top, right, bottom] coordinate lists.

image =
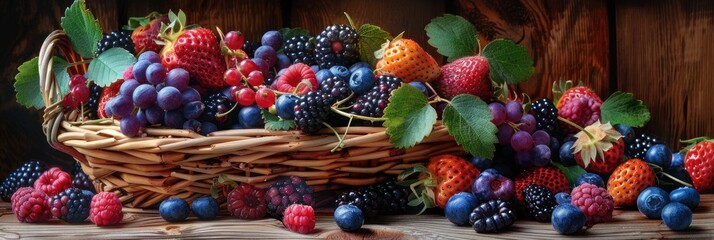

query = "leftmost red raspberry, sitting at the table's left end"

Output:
[[12, 187, 52, 223]]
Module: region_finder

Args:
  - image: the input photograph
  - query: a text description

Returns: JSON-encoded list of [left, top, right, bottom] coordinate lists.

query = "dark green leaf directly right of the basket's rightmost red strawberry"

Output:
[[483, 39, 534, 84]]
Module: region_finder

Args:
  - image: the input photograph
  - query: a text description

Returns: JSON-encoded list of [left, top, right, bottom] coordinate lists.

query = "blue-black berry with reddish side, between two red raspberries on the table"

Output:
[[48, 187, 92, 223]]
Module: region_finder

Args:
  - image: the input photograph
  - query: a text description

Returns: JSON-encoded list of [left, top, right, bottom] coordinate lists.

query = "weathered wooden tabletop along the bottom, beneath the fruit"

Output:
[[0, 194, 714, 239]]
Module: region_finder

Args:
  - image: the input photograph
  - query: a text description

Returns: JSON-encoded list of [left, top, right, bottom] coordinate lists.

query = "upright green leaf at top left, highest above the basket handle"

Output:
[[60, 0, 102, 58]]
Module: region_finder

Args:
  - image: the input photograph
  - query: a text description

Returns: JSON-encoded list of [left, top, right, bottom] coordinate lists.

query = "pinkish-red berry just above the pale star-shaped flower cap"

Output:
[[558, 96, 602, 132]]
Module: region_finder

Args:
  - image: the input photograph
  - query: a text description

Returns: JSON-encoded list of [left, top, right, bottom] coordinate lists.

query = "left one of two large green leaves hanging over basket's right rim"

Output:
[[383, 84, 437, 148]]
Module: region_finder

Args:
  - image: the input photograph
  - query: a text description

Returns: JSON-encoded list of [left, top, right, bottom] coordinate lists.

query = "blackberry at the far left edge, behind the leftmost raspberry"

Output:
[[0, 160, 46, 202]]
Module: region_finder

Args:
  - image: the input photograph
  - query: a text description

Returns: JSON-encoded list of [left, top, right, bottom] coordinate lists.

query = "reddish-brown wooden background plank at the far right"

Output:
[[615, 1, 714, 147]]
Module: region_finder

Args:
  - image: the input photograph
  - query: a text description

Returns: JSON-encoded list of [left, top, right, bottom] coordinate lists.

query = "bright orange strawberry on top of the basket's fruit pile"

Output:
[[377, 34, 441, 82]]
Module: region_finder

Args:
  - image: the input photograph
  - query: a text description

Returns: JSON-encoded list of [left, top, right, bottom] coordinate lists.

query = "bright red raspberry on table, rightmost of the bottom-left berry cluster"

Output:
[[89, 192, 124, 226]]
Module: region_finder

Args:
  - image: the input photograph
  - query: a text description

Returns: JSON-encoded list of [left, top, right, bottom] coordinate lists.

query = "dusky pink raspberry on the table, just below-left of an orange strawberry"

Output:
[[570, 183, 615, 225]]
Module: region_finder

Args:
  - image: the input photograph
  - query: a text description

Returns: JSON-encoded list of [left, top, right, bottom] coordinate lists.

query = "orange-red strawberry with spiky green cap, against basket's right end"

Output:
[[397, 154, 480, 212]]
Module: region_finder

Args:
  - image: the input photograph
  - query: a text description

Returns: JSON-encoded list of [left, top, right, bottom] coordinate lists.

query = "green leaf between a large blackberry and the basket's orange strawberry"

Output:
[[357, 24, 392, 66]]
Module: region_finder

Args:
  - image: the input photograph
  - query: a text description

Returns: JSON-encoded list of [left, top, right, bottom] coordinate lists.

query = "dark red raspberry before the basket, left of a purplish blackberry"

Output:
[[228, 183, 268, 219]]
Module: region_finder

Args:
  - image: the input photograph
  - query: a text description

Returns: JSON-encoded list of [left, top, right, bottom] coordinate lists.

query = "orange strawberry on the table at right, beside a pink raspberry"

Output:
[[607, 158, 656, 207]]
